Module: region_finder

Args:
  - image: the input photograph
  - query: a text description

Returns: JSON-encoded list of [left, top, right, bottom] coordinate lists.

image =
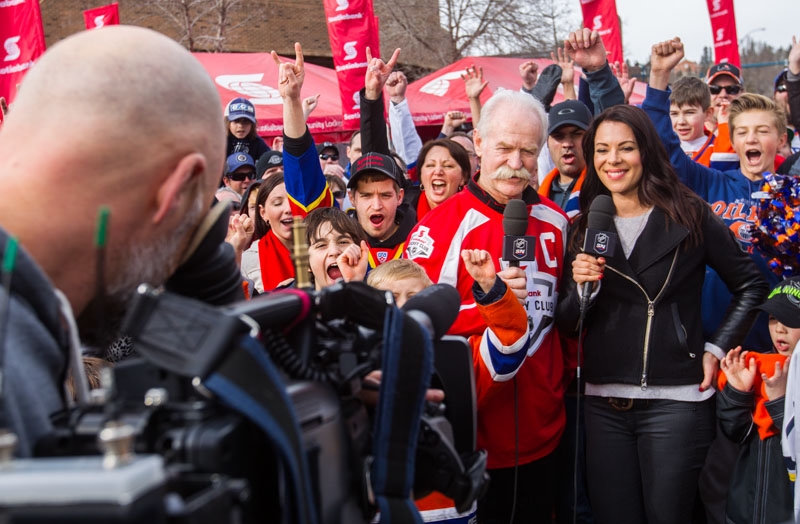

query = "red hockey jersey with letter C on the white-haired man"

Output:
[[406, 181, 567, 468]]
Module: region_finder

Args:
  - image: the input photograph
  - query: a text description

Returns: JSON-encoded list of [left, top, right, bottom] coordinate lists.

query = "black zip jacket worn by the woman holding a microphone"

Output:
[[556, 206, 768, 389]]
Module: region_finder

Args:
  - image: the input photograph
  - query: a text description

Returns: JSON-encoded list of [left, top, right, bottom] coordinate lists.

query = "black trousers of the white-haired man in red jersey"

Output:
[[478, 451, 558, 524]]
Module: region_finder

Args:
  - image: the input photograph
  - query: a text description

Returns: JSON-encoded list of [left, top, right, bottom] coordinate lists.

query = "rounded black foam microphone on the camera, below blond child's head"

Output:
[[400, 284, 461, 340]]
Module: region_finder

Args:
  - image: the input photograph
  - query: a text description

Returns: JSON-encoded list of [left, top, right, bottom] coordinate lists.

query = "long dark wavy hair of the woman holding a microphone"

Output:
[[570, 105, 706, 250]]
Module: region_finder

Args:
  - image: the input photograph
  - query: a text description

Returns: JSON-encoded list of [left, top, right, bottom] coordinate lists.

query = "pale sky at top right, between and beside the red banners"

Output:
[[608, 0, 800, 63]]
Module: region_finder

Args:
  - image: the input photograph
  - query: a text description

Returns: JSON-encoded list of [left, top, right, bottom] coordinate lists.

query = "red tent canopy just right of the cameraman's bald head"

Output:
[[194, 53, 352, 142]]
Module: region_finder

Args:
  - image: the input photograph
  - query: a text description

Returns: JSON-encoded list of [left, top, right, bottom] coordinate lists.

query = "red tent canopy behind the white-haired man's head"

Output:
[[406, 57, 646, 131]]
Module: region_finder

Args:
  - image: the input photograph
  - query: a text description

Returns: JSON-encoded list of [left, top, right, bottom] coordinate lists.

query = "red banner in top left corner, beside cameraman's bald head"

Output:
[[0, 0, 45, 104]]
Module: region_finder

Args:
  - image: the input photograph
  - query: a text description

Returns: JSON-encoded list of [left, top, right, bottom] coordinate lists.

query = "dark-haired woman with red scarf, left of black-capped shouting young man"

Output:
[[242, 175, 295, 293]]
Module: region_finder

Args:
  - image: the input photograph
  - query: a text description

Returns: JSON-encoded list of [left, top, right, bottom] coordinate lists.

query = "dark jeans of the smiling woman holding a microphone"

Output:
[[585, 397, 716, 524]]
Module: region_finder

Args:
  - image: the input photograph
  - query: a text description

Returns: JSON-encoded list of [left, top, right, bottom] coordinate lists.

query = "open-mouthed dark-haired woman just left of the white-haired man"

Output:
[[412, 138, 472, 221]]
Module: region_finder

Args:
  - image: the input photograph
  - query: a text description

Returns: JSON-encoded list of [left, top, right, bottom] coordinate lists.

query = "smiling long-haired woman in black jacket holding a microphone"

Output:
[[556, 105, 767, 524]]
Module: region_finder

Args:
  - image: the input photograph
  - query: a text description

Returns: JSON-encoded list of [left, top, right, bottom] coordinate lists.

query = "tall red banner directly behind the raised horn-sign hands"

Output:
[[323, 0, 381, 129]]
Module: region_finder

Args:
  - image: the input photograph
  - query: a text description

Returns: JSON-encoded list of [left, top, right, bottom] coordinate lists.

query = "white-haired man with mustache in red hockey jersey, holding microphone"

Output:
[[406, 90, 568, 523]]
